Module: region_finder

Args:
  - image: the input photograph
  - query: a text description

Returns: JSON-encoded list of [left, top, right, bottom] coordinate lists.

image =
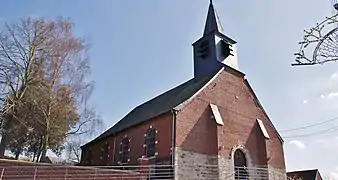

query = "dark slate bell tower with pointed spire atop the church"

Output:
[[193, 0, 238, 78]]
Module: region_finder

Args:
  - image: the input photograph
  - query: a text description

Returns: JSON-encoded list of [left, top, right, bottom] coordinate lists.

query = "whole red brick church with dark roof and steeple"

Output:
[[81, 2, 286, 179]]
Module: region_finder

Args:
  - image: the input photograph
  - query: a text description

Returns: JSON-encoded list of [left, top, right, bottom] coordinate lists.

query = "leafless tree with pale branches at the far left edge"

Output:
[[0, 19, 49, 156]]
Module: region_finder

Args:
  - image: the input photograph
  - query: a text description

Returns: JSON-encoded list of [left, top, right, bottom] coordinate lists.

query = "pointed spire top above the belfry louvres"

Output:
[[203, 0, 223, 36]]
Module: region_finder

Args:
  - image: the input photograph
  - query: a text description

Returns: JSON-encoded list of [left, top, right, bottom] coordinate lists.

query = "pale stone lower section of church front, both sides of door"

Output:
[[175, 147, 287, 180]]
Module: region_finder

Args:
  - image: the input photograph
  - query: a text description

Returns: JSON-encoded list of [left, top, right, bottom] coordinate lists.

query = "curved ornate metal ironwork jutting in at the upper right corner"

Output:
[[292, 0, 338, 66]]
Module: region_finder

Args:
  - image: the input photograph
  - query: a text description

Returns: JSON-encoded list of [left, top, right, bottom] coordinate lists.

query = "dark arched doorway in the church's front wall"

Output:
[[234, 149, 249, 179]]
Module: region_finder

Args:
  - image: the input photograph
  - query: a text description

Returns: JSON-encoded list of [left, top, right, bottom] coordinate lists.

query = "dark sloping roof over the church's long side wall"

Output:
[[84, 76, 213, 146]]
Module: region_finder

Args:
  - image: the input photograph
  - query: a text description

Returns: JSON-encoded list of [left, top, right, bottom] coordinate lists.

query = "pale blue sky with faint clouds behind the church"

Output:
[[0, 0, 338, 179]]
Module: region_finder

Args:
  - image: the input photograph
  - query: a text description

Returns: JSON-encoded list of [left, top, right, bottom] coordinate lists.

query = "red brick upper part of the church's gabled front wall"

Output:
[[176, 69, 285, 169]]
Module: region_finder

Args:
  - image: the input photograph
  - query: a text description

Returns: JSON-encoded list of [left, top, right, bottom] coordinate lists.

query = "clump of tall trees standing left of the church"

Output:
[[0, 18, 102, 161]]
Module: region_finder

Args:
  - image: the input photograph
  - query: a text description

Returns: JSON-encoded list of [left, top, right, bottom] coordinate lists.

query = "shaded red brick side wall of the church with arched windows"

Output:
[[81, 112, 173, 165]]
